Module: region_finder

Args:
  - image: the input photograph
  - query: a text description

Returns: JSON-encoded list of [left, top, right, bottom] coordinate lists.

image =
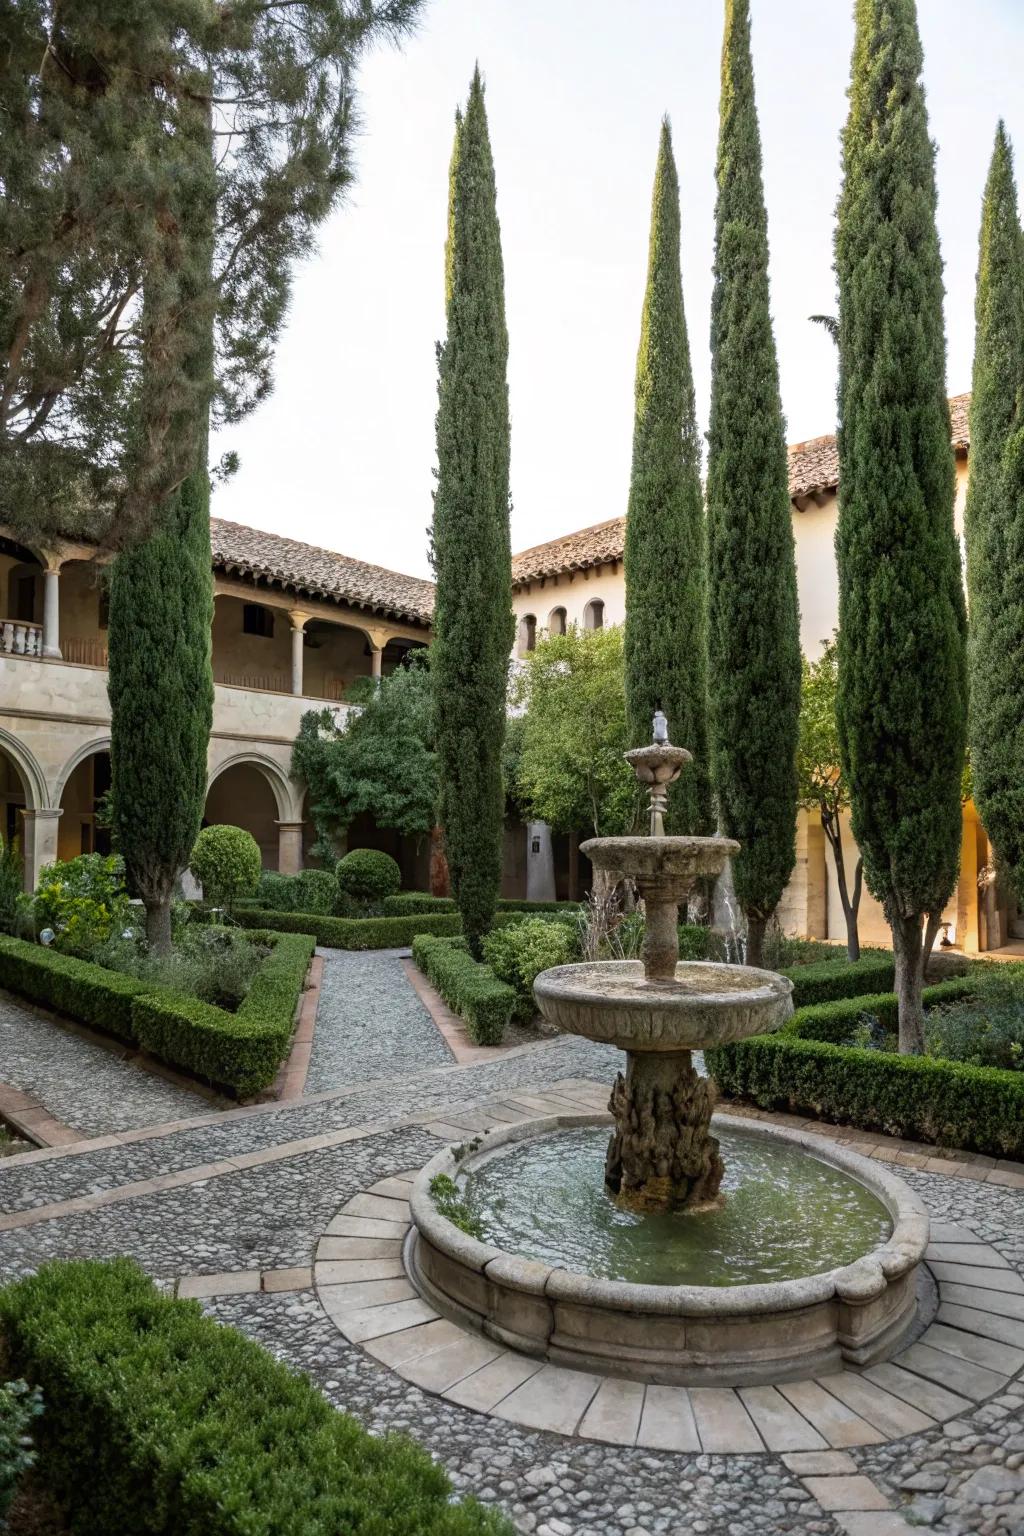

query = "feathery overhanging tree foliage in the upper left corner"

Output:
[[0, 0, 419, 539]]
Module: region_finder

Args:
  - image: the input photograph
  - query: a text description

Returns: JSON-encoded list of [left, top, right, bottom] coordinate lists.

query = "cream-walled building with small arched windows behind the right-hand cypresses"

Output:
[[513, 395, 1024, 952]]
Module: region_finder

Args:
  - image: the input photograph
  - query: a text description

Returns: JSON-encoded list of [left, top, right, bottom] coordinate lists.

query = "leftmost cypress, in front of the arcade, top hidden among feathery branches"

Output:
[[107, 89, 216, 954]]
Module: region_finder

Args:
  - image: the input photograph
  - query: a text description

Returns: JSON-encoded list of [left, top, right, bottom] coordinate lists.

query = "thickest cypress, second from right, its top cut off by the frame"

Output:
[[835, 0, 967, 1052]]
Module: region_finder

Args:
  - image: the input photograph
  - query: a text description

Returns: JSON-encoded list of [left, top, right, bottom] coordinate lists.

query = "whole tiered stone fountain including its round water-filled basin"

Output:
[[407, 714, 927, 1384]]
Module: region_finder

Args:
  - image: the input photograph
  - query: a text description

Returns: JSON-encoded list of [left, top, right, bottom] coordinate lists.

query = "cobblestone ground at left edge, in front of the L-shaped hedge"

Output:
[[0, 992, 210, 1137]]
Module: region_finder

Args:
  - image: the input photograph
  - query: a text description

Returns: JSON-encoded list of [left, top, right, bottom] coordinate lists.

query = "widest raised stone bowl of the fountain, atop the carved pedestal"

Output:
[[533, 958, 792, 1052]]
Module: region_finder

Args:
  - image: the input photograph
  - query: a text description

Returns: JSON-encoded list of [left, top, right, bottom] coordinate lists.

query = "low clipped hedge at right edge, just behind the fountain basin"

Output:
[[705, 977, 1024, 1158]]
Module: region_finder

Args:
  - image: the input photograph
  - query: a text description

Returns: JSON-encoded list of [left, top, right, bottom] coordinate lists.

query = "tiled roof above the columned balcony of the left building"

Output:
[[210, 518, 434, 624]]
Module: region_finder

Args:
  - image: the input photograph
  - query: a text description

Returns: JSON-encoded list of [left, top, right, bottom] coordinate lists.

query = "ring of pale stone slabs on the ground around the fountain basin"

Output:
[[315, 1117, 1024, 1453]]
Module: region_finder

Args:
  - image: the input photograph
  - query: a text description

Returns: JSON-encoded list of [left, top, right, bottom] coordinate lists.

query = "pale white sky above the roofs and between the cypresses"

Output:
[[213, 0, 1024, 576]]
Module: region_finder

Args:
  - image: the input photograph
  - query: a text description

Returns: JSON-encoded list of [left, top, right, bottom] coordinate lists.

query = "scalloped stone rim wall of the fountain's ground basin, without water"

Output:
[[405, 1115, 929, 1385]]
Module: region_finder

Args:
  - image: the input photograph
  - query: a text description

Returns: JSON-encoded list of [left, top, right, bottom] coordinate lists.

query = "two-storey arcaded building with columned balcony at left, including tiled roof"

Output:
[[0, 519, 433, 888]]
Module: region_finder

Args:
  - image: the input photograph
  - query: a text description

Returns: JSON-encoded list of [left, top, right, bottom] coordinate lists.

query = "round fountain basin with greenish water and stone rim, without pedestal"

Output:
[[405, 1115, 927, 1385]]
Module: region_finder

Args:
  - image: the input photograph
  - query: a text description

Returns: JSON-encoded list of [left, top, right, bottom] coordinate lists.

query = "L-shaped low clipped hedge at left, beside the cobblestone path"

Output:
[[0, 931, 315, 1095]]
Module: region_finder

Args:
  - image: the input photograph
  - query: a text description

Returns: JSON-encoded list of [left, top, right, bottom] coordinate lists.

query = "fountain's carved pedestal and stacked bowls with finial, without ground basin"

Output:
[[534, 711, 792, 1210]]
